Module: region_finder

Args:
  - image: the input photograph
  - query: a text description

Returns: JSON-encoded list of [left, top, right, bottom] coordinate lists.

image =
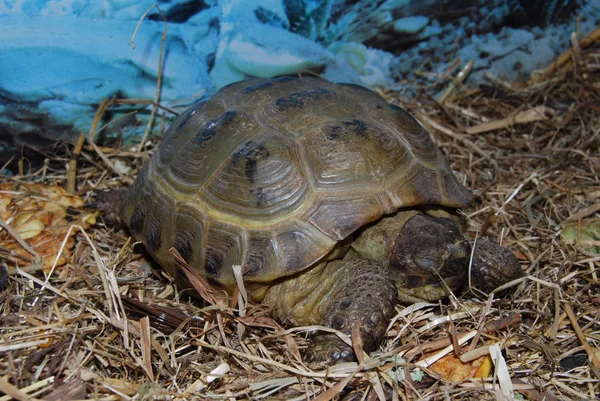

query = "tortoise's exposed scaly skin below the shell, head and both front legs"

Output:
[[263, 210, 522, 361]]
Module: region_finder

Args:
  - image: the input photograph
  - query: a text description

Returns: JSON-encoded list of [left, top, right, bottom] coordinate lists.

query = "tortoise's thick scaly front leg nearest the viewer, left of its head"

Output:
[[263, 258, 397, 362]]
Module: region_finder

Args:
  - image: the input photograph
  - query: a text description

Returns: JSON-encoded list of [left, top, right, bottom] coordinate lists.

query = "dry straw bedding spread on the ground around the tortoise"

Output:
[[0, 35, 600, 401]]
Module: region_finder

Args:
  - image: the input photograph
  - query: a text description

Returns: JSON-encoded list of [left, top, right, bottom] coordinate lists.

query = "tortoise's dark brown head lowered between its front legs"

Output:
[[390, 213, 471, 303]]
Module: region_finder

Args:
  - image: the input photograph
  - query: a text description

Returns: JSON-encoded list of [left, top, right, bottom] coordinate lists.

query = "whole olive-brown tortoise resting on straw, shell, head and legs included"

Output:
[[96, 76, 522, 361]]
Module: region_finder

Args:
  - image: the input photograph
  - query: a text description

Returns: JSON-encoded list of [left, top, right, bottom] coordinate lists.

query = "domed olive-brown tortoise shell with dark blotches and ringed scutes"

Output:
[[121, 77, 471, 288]]
